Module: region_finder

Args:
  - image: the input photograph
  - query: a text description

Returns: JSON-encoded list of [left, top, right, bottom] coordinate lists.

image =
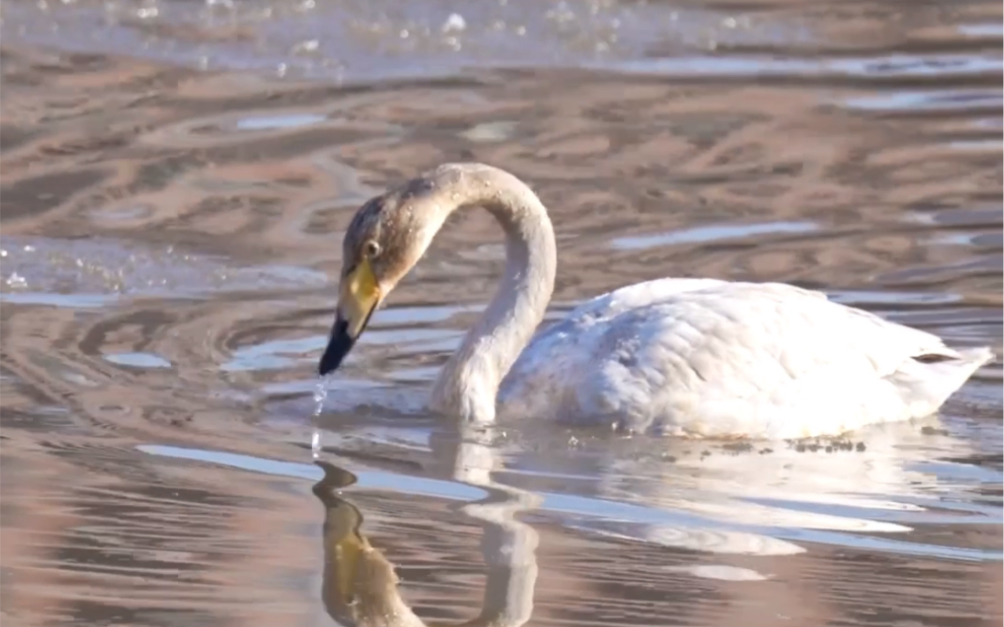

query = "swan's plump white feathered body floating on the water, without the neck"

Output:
[[500, 279, 992, 438]]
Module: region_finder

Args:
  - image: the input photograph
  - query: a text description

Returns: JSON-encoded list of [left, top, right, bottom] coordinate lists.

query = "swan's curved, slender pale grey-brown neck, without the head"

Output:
[[431, 165, 557, 422]]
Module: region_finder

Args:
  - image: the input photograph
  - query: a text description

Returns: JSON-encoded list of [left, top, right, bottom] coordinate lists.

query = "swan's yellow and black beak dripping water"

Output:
[[317, 259, 381, 376]]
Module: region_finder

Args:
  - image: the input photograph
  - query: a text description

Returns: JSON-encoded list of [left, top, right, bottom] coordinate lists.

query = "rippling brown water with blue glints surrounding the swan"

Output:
[[0, 0, 1004, 625]]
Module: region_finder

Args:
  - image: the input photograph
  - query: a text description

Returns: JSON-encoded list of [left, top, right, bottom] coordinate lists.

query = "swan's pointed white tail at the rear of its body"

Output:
[[895, 346, 994, 418]]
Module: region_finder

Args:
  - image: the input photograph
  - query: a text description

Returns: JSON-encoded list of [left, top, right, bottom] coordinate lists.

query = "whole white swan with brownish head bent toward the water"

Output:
[[318, 163, 993, 439]]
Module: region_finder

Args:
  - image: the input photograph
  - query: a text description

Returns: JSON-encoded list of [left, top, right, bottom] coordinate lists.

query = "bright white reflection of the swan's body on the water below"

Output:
[[485, 415, 1000, 557]]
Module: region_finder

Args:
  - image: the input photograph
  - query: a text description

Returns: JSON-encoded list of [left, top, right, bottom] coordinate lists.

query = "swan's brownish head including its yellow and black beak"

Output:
[[318, 176, 449, 376]]
